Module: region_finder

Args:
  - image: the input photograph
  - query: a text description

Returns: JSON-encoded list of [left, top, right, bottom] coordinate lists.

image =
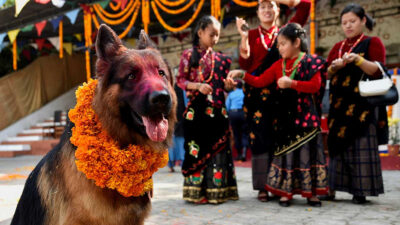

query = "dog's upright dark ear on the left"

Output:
[[96, 24, 122, 61]]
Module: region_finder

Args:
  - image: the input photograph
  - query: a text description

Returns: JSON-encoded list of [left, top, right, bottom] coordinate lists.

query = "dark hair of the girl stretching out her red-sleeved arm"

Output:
[[278, 23, 308, 52]]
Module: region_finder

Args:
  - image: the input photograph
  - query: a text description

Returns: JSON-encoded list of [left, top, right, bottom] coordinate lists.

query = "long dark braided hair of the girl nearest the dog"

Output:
[[189, 15, 219, 68]]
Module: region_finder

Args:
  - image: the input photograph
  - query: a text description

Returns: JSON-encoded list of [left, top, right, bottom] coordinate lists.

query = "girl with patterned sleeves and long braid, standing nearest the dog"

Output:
[[177, 16, 239, 204]]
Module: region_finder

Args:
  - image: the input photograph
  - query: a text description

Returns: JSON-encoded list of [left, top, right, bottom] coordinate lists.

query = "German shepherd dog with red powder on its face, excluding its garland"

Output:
[[11, 25, 176, 225]]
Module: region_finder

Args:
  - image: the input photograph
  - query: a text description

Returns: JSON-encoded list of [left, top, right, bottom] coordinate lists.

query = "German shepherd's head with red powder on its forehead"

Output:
[[93, 25, 176, 148]]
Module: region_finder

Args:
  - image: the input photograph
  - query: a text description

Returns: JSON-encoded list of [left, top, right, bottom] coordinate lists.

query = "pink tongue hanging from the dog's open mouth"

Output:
[[142, 116, 168, 142]]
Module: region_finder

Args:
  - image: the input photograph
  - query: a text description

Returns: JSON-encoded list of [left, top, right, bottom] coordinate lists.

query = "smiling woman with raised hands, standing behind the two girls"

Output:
[[236, 0, 311, 202]]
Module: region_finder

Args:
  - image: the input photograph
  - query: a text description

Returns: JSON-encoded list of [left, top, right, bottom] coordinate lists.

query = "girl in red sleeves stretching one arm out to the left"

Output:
[[228, 23, 328, 207]]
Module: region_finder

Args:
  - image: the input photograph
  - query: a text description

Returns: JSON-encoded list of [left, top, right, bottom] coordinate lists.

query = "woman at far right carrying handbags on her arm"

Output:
[[326, 4, 388, 204]]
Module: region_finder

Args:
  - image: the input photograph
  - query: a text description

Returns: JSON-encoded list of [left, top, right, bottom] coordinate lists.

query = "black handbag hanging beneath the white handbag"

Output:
[[365, 62, 399, 106]]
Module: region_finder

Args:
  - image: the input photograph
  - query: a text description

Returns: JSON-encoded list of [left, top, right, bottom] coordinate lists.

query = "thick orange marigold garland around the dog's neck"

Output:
[[69, 80, 168, 197]]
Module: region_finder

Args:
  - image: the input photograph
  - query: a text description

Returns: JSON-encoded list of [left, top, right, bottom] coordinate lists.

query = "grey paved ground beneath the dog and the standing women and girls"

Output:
[[0, 156, 400, 225]]
